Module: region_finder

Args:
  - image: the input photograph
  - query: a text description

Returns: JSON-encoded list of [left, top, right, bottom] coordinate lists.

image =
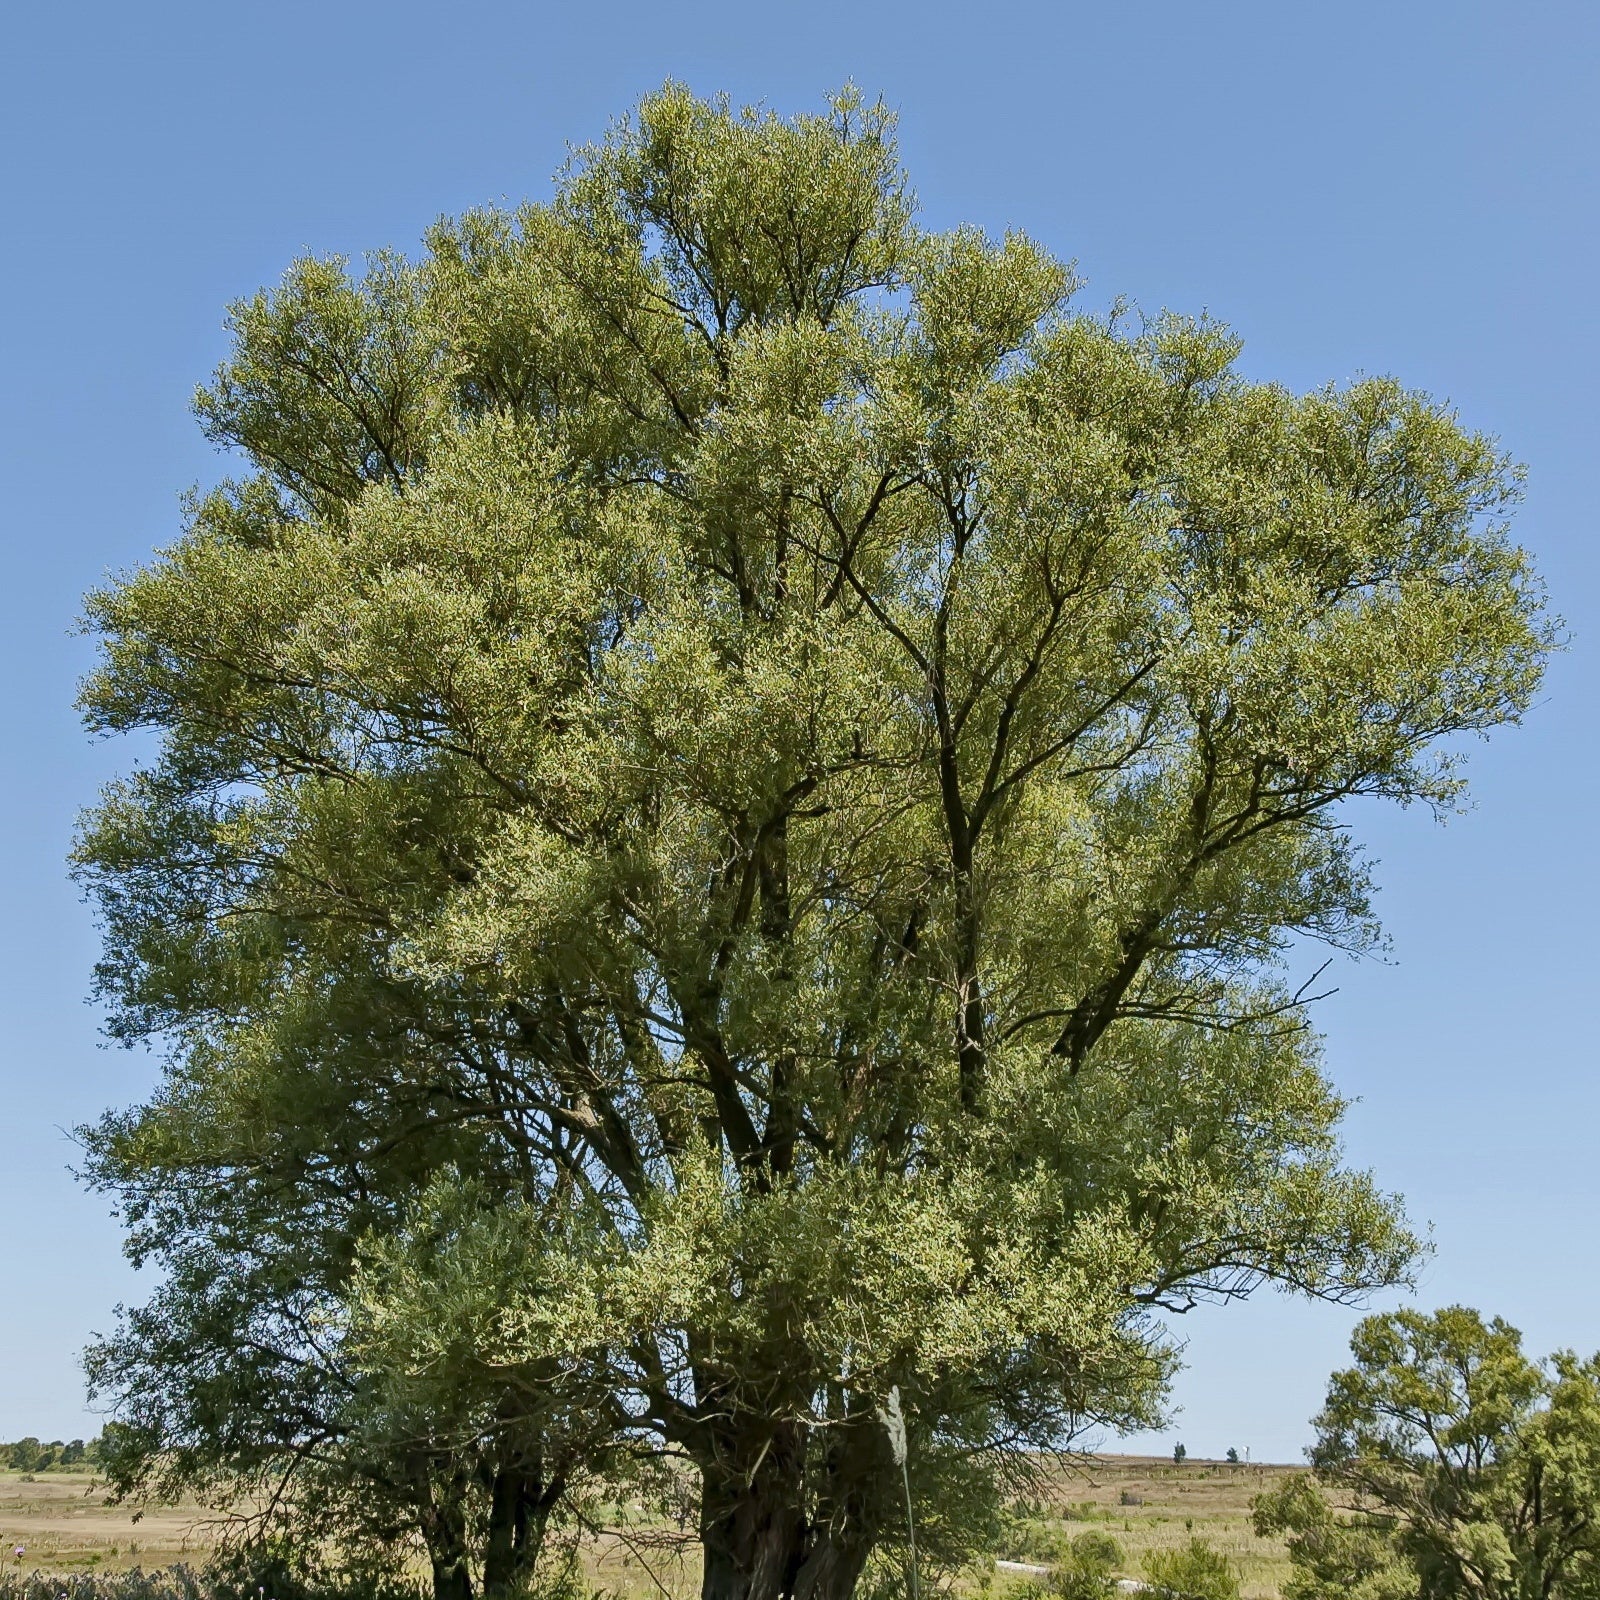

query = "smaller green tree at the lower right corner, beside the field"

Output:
[[1254, 1306, 1600, 1600]]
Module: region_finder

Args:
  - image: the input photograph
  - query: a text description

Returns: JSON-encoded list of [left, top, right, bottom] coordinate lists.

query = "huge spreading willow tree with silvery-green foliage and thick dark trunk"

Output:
[[80, 88, 1549, 1600]]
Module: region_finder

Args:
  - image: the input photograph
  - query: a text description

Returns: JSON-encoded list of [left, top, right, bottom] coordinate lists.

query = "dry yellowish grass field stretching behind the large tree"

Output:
[[0, 1456, 1298, 1600]]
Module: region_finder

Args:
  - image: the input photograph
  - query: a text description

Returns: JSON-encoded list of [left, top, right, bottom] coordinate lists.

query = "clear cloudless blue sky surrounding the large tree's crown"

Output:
[[0, 0, 1600, 1459]]
